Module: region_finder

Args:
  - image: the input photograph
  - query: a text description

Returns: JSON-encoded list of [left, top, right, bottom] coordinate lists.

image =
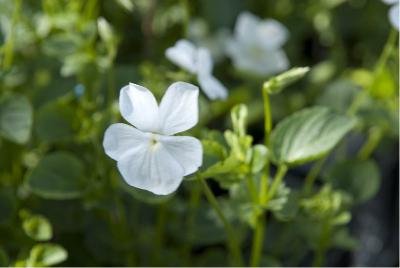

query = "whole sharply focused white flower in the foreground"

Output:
[[103, 82, 203, 195]]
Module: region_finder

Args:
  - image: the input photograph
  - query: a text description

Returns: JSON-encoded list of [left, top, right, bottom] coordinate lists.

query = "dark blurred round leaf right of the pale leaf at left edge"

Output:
[[35, 102, 75, 142]]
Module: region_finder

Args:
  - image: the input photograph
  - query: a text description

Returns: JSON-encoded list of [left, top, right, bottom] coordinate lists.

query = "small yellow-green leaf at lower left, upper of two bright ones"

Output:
[[22, 214, 53, 241]]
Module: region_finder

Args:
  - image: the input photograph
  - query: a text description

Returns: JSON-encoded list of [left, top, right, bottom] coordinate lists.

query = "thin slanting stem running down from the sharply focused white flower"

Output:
[[198, 176, 243, 266]]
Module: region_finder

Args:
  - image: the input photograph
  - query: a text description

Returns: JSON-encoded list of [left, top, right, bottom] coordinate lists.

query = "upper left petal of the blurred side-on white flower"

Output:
[[165, 40, 197, 73]]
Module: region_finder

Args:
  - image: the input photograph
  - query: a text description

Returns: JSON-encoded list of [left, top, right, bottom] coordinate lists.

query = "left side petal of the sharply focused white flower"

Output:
[[103, 123, 151, 161]]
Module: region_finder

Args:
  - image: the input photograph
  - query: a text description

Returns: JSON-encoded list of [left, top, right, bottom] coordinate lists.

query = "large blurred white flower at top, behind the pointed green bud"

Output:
[[227, 12, 289, 76]]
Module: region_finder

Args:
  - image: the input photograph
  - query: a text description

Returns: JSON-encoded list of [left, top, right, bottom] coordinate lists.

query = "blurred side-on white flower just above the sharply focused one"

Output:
[[165, 40, 228, 100]]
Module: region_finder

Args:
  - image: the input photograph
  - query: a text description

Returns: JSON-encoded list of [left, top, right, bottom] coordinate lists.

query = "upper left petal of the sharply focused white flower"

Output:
[[119, 83, 158, 132]]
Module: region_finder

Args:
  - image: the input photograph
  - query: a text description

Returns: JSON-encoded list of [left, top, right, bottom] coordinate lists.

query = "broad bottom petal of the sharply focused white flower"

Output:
[[117, 138, 184, 195]]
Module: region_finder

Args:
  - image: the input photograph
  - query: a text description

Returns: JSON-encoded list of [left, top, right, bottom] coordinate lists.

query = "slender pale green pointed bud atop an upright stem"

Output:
[[263, 67, 310, 94]]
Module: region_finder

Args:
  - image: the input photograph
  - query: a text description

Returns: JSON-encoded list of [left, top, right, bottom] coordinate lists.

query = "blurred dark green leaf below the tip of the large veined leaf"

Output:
[[324, 160, 381, 203]]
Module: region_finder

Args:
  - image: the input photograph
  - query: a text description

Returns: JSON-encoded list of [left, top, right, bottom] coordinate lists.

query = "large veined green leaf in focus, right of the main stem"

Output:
[[271, 107, 355, 165]]
